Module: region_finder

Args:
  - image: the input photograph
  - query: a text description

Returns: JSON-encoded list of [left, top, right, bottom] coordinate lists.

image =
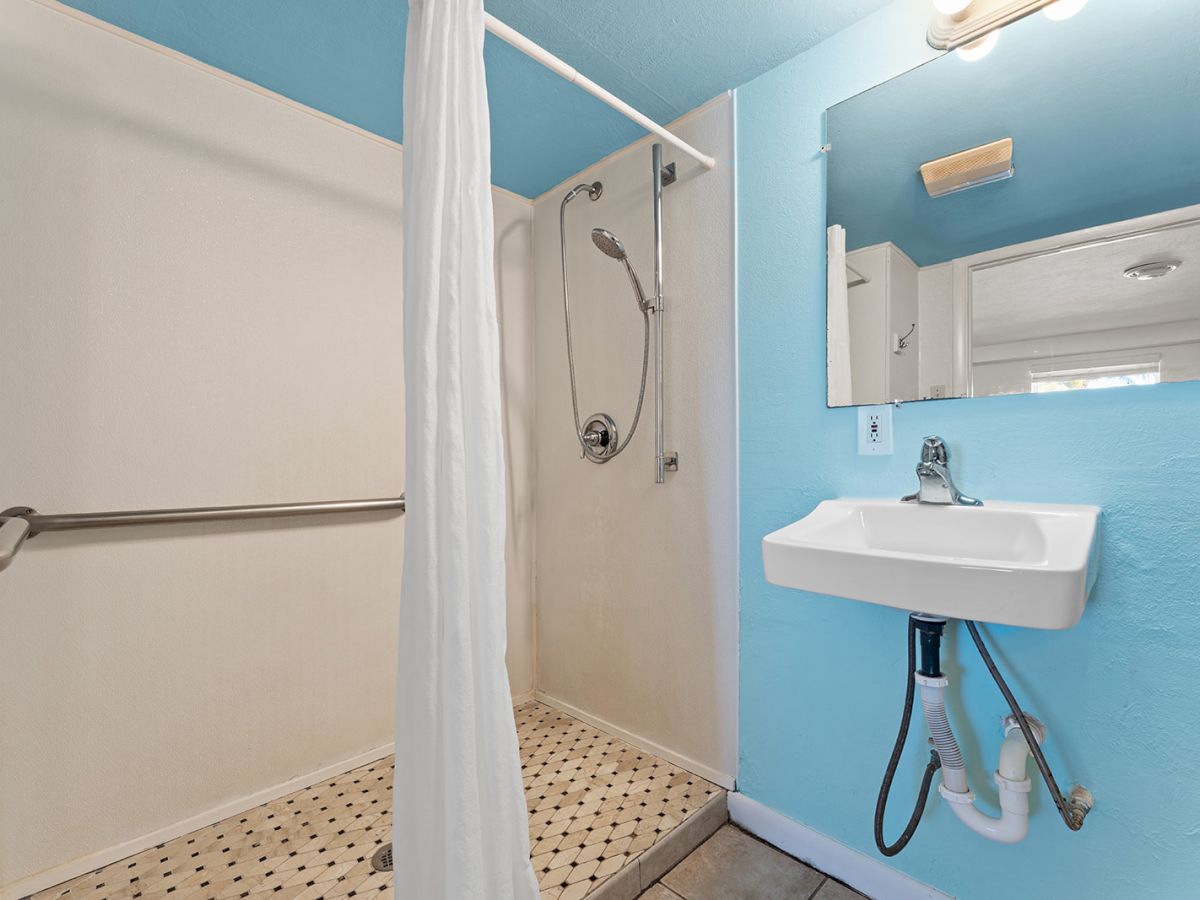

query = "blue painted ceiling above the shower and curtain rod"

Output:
[[54, 0, 887, 197]]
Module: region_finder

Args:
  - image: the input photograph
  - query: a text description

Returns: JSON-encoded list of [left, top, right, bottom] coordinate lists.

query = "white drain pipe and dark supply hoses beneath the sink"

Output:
[[875, 613, 1092, 857]]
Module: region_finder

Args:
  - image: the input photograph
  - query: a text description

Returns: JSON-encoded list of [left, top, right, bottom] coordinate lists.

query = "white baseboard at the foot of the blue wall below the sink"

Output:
[[728, 793, 954, 900]]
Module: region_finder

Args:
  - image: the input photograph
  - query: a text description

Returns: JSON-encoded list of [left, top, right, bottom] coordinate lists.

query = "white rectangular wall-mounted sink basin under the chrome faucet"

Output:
[[762, 500, 1100, 629]]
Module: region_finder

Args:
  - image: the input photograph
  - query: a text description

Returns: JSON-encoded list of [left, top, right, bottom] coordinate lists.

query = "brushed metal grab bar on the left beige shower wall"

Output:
[[0, 494, 404, 571]]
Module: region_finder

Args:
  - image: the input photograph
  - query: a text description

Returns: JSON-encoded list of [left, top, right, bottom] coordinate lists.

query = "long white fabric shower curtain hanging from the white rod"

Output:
[[392, 0, 538, 900]]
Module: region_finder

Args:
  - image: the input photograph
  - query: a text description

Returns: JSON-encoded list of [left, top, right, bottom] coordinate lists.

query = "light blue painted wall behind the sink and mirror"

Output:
[[737, 0, 1200, 900]]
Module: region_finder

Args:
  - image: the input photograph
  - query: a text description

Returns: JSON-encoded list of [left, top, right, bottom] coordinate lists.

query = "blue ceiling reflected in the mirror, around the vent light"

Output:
[[827, 0, 1200, 265]]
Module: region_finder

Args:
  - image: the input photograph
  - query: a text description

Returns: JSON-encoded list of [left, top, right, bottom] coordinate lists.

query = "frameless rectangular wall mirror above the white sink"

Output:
[[827, 2, 1200, 406]]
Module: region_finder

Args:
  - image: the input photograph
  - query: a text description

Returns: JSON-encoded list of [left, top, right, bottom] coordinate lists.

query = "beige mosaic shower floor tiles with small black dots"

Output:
[[34, 701, 721, 900]]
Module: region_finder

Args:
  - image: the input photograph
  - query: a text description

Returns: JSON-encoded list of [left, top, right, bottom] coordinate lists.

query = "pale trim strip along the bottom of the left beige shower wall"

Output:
[[7, 743, 396, 898]]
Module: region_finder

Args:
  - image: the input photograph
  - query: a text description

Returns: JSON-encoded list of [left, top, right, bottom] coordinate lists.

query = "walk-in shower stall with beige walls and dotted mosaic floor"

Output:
[[0, 0, 737, 898]]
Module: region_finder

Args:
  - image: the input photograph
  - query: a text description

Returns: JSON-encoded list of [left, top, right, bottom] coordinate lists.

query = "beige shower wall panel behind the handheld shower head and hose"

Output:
[[534, 97, 738, 784]]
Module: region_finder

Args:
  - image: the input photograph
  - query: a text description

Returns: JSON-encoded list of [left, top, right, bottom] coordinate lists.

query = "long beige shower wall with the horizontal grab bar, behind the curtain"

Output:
[[0, 0, 533, 895]]
